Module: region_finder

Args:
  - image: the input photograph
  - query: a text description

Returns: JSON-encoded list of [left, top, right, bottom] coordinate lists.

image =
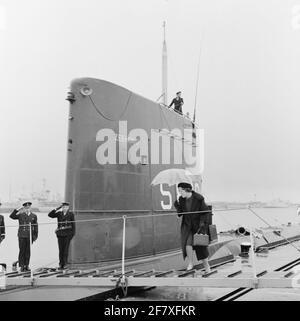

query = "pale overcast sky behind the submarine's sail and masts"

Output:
[[0, 0, 300, 202]]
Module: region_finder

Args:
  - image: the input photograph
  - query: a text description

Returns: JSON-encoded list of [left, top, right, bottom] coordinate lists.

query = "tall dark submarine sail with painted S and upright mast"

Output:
[[65, 23, 201, 265]]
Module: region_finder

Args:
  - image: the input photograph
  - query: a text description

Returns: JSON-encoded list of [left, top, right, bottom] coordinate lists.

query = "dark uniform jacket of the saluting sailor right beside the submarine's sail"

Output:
[[48, 209, 75, 238]]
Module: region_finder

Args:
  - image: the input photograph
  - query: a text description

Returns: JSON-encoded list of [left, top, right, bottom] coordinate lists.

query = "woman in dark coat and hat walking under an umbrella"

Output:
[[174, 183, 210, 272]]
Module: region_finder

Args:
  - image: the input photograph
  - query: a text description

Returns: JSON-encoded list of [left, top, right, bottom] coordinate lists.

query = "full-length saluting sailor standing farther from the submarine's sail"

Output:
[[9, 202, 38, 272]]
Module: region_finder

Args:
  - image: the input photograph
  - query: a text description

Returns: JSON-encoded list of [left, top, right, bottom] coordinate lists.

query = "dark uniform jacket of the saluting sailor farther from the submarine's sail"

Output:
[[9, 210, 38, 241]]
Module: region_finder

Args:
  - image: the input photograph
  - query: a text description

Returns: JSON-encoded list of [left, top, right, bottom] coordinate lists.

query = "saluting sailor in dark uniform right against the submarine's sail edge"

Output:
[[48, 202, 75, 270]]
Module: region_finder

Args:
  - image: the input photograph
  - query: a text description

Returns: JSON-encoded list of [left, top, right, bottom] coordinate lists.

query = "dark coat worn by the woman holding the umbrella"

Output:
[[174, 191, 210, 258]]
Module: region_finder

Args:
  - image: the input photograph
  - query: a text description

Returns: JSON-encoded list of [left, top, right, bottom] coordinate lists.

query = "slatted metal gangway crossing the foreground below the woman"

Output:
[[1, 269, 296, 289]]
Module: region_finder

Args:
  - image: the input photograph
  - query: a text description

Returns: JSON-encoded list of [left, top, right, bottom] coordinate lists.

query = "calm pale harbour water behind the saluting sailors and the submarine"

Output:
[[0, 207, 299, 268]]
